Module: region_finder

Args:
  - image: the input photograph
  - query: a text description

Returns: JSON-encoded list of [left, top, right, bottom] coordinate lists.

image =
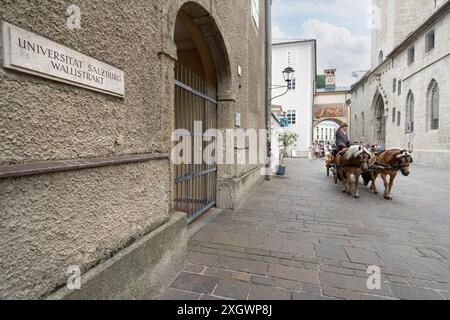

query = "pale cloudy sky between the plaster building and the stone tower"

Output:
[[272, 0, 372, 86]]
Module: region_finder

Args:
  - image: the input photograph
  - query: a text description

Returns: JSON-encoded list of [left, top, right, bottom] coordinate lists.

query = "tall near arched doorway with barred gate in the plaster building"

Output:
[[172, 2, 230, 223]]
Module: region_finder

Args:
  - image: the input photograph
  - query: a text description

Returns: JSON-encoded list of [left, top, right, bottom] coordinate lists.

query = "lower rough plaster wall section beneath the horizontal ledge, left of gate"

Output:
[[0, 161, 169, 299]]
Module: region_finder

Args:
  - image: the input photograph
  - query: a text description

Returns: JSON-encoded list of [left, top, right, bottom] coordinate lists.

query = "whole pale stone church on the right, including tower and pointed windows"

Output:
[[351, 0, 450, 167]]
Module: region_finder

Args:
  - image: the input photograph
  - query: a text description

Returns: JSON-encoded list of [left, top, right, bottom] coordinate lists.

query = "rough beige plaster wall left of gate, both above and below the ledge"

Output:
[[0, 0, 172, 298]]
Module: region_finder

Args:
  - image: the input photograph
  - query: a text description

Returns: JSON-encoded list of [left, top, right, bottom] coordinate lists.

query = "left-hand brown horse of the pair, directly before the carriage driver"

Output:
[[336, 146, 376, 198]]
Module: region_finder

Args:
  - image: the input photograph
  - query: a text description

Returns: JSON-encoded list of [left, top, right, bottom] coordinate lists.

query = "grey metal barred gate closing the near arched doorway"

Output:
[[174, 64, 217, 223]]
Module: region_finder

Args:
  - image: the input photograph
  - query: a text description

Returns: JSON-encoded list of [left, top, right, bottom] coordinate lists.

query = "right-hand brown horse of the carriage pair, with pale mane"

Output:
[[363, 149, 413, 200]]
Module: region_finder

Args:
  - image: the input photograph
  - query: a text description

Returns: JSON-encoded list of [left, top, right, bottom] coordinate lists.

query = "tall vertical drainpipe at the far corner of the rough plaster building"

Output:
[[264, 0, 272, 181]]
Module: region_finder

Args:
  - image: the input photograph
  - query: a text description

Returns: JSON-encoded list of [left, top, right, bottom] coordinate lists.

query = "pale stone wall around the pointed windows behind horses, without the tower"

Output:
[[351, 8, 450, 167]]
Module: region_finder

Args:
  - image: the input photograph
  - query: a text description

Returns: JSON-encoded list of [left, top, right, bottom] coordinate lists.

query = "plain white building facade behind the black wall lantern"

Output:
[[272, 40, 317, 157]]
